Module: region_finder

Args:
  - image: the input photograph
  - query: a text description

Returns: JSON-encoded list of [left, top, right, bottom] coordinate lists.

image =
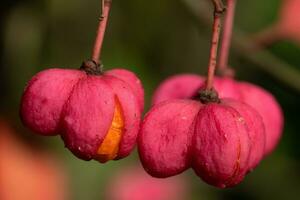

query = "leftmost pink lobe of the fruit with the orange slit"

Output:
[[20, 69, 86, 135]]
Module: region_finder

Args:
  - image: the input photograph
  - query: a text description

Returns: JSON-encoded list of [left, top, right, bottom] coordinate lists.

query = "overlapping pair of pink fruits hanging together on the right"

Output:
[[138, 75, 283, 188]]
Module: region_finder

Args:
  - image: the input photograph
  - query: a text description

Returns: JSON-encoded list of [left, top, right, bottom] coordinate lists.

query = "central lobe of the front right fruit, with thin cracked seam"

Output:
[[193, 99, 254, 188]]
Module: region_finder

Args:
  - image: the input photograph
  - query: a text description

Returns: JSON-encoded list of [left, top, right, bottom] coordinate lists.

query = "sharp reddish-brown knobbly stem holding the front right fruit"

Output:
[[206, 0, 225, 90]]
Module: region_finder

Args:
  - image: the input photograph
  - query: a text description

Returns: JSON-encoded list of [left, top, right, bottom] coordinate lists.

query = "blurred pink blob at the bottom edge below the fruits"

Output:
[[105, 166, 189, 200]]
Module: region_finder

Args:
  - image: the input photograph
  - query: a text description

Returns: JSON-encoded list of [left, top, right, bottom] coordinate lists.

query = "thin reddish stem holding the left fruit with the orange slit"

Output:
[[92, 0, 112, 64]]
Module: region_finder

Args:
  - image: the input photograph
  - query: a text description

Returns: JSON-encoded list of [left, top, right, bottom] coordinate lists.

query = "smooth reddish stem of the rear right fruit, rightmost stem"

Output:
[[218, 0, 236, 75]]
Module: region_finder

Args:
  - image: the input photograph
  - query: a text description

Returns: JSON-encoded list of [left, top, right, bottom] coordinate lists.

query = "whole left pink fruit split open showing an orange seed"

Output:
[[21, 62, 144, 162]]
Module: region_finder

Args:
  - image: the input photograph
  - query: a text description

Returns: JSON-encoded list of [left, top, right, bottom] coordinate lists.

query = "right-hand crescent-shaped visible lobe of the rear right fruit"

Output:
[[238, 82, 284, 155]]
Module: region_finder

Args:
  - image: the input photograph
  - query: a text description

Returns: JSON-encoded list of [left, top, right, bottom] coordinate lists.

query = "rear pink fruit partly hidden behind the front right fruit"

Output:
[[153, 74, 284, 155]]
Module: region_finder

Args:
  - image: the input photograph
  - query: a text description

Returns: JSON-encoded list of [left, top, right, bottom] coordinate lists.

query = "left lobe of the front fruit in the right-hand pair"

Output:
[[138, 100, 201, 178]]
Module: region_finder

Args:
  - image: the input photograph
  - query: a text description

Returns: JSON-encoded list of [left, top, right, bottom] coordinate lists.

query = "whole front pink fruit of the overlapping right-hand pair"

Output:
[[138, 91, 265, 188]]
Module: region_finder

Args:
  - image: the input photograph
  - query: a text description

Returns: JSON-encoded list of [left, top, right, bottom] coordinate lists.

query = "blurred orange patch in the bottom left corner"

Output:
[[0, 119, 66, 200]]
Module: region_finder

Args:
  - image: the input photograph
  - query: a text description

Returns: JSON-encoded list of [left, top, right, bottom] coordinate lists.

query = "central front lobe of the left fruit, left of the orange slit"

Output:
[[62, 76, 115, 160]]
